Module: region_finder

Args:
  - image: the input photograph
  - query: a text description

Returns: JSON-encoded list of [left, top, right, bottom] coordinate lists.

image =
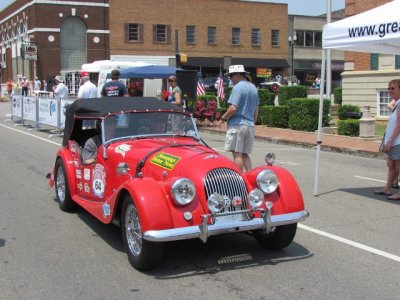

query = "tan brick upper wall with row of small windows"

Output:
[[110, 0, 288, 59]]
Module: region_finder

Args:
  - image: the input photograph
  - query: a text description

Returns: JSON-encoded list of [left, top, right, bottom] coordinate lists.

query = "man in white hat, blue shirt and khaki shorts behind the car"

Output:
[[220, 65, 260, 171]]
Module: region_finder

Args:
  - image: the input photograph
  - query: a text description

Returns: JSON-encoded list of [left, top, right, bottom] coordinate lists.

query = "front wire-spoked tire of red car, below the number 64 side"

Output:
[[121, 196, 164, 270]]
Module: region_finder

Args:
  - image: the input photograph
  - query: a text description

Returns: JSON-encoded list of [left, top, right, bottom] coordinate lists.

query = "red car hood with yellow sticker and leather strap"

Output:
[[107, 138, 236, 179]]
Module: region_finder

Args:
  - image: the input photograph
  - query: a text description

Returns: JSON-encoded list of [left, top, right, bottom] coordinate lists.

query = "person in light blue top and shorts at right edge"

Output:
[[374, 79, 400, 200]]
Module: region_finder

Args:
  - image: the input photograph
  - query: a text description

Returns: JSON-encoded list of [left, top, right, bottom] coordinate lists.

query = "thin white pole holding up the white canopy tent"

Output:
[[314, 49, 326, 196]]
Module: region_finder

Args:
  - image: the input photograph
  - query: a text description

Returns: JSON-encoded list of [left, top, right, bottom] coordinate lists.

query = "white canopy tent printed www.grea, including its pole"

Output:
[[314, 0, 400, 196]]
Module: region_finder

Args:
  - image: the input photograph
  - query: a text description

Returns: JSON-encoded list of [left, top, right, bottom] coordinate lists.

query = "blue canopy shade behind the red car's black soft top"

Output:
[[115, 65, 181, 79]]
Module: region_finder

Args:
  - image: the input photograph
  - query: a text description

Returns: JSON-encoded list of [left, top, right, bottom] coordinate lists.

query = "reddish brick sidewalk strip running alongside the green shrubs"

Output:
[[199, 124, 387, 158]]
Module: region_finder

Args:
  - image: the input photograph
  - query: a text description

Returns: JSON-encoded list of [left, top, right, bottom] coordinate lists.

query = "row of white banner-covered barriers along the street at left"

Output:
[[11, 95, 75, 132]]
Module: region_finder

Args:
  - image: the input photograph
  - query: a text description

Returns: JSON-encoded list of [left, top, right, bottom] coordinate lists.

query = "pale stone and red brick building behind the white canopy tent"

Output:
[[342, 0, 400, 120]]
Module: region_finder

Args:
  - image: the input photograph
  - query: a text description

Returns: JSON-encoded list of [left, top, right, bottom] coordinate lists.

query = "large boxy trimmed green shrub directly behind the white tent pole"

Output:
[[288, 98, 330, 131]]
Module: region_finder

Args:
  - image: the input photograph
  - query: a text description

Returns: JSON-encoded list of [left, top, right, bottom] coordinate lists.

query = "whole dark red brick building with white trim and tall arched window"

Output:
[[0, 0, 110, 93]]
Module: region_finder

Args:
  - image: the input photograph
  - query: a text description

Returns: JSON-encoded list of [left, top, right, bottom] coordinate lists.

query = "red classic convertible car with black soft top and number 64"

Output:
[[48, 97, 308, 270]]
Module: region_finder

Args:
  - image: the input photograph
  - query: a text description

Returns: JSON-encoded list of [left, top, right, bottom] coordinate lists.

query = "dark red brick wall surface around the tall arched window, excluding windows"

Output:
[[0, 0, 110, 82]]
